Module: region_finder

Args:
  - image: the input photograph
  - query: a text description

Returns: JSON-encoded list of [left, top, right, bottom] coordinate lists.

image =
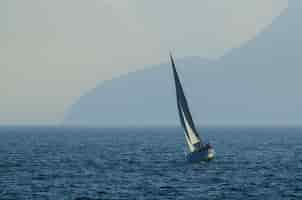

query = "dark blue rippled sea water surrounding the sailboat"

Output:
[[0, 127, 302, 200]]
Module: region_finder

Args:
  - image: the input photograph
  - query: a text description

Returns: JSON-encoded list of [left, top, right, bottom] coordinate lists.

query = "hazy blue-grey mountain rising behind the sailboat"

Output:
[[64, 1, 302, 126]]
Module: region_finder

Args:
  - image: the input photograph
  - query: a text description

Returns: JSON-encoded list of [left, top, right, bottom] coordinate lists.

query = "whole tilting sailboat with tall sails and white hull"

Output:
[[170, 54, 215, 162]]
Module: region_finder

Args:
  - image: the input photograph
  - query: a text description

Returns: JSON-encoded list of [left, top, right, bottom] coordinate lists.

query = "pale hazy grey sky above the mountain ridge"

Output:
[[0, 0, 287, 124]]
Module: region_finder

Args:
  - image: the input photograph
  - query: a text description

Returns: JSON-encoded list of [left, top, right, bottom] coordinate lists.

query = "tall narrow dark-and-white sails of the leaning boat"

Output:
[[170, 55, 203, 152]]
